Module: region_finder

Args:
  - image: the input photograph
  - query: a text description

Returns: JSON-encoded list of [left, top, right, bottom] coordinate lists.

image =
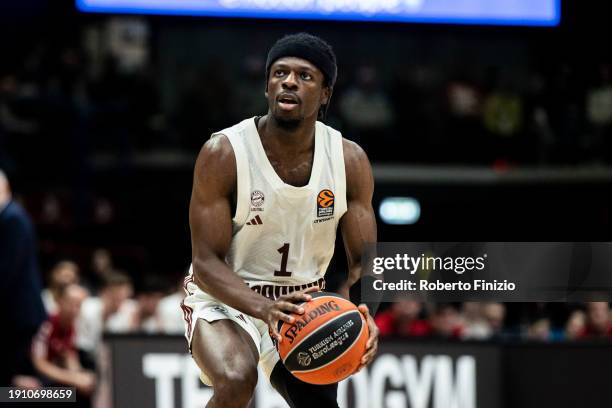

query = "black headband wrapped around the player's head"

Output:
[[266, 33, 338, 88]]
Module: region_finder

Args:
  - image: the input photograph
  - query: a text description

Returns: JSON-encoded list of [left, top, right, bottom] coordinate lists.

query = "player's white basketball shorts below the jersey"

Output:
[[181, 276, 280, 385]]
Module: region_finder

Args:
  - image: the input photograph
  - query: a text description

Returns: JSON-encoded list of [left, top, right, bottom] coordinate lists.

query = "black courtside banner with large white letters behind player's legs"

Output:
[[104, 335, 503, 408]]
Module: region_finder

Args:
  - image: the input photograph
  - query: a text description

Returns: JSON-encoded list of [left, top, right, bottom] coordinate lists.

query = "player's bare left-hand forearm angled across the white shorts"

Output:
[[193, 257, 272, 319]]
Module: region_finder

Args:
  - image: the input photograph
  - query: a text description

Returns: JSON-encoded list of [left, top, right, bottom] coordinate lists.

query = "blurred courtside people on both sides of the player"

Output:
[[0, 167, 612, 407]]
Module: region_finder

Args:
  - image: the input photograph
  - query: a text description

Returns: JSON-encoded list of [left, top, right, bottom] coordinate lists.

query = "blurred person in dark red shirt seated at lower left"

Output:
[[32, 284, 96, 406]]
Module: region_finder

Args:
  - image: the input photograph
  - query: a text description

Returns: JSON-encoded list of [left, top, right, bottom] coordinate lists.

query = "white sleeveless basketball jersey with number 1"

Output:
[[214, 118, 347, 298]]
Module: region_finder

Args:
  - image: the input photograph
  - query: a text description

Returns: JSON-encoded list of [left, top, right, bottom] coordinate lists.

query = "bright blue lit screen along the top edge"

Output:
[[76, 0, 561, 26]]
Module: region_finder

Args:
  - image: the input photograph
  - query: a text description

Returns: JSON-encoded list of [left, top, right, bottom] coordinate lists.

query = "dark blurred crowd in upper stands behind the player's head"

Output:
[[0, 18, 612, 178]]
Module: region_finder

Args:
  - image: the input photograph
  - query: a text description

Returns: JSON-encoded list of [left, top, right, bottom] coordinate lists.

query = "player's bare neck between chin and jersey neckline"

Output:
[[257, 114, 316, 152]]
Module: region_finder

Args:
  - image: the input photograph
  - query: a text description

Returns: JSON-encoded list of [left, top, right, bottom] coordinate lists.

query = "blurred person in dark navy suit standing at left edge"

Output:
[[0, 170, 46, 386]]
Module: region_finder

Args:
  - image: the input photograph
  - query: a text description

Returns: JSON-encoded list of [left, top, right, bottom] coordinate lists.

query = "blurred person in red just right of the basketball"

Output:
[[375, 299, 431, 337]]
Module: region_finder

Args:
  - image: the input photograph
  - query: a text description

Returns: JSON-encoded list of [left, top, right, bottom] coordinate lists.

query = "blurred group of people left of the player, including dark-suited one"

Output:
[[0, 164, 184, 407]]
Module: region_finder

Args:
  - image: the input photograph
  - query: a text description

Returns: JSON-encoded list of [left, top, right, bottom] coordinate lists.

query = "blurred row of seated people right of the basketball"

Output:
[[375, 299, 612, 342]]
